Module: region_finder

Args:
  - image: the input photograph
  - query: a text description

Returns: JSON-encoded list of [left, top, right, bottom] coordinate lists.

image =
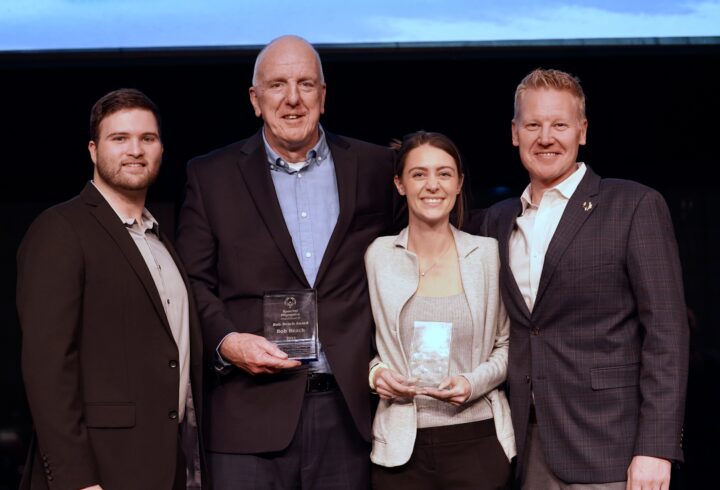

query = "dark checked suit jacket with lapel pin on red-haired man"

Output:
[[475, 168, 689, 483]]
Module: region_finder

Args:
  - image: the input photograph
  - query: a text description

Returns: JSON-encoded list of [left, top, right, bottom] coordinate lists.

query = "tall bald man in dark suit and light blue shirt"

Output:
[[173, 36, 397, 490]]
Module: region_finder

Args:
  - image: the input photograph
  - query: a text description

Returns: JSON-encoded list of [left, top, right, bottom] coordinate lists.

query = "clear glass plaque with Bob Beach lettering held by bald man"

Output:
[[263, 289, 318, 361]]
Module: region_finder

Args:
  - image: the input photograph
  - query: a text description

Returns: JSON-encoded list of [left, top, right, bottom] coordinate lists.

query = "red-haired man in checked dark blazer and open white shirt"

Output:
[[476, 69, 688, 490]]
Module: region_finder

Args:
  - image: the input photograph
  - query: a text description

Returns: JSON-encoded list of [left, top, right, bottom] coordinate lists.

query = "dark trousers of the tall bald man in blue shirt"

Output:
[[208, 390, 370, 490]]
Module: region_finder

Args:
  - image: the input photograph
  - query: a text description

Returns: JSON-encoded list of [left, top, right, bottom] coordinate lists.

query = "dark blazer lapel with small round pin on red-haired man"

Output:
[[534, 167, 600, 309]]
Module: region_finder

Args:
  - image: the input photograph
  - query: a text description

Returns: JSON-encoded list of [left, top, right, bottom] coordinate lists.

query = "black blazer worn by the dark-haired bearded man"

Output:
[[17, 183, 202, 490]]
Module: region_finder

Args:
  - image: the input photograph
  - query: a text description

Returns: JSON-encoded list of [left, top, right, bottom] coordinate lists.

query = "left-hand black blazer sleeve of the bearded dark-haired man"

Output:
[[16, 210, 99, 489]]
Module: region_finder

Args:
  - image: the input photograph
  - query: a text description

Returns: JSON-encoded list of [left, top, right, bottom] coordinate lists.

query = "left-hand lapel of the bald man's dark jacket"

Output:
[[233, 133, 310, 288]]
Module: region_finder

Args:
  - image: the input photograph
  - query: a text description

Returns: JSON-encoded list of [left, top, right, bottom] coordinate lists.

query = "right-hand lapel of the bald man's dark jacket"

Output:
[[315, 132, 357, 285]]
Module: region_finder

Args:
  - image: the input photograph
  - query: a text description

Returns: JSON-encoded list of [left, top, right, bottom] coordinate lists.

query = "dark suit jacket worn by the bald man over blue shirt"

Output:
[[177, 132, 397, 453]]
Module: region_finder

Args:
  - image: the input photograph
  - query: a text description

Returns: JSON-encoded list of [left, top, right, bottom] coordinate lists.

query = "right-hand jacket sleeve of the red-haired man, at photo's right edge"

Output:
[[627, 191, 689, 461]]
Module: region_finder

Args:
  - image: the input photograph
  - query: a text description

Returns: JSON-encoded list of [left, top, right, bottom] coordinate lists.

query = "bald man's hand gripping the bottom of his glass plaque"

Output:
[[220, 333, 300, 374]]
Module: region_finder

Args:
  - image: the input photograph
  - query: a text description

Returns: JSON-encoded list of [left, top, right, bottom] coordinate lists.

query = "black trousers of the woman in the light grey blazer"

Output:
[[372, 419, 510, 490]]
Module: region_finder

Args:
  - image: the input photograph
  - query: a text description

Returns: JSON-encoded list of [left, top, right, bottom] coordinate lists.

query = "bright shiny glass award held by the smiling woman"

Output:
[[410, 321, 452, 387]]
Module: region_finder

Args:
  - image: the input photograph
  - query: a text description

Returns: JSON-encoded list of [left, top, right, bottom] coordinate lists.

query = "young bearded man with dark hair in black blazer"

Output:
[[17, 89, 207, 490]]
